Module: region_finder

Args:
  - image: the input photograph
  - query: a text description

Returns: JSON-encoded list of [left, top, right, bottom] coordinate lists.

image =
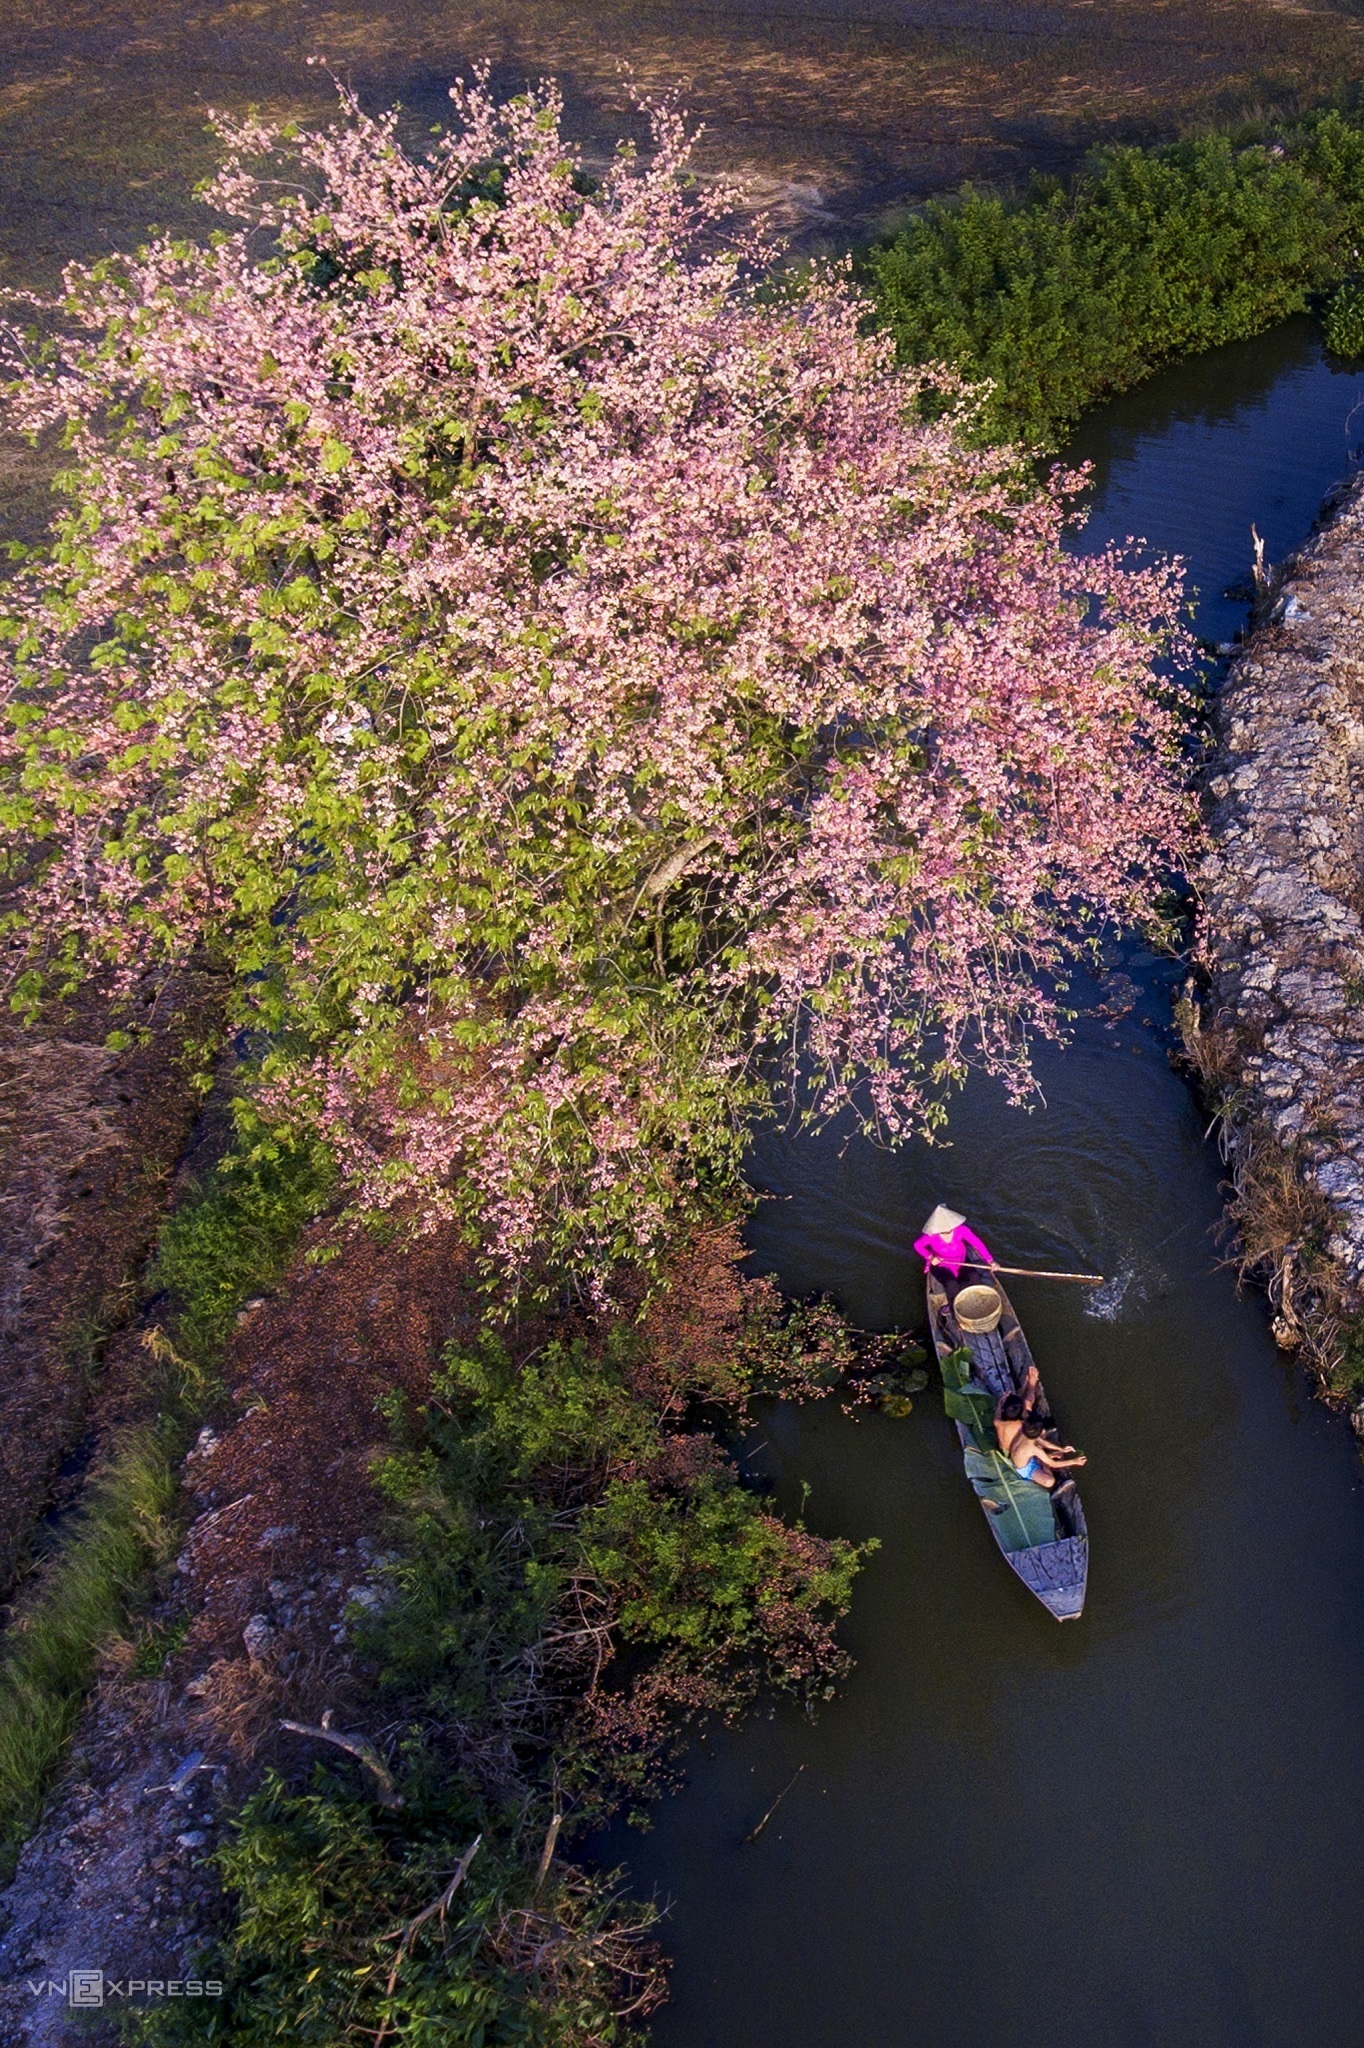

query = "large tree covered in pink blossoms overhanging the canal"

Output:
[[0, 82, 1188, 1264]]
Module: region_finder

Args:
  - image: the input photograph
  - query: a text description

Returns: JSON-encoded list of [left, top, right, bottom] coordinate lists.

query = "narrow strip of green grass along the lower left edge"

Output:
[[0, 1143, 332, 1868]]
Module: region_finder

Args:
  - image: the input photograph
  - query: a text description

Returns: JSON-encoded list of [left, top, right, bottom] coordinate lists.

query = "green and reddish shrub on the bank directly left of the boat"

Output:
[[368, 1329, 862, 1810]]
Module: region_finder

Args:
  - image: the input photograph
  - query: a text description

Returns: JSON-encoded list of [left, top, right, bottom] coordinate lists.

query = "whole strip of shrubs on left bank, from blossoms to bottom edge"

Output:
[[135, 1239, 872, 2048]]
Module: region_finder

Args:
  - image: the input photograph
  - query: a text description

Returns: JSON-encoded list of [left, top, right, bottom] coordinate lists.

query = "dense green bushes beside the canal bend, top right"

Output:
[[866, 111, 1364, 446]]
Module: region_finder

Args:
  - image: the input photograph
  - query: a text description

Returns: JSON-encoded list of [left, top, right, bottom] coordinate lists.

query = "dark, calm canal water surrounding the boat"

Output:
[[602, 322, 1364, 2048]]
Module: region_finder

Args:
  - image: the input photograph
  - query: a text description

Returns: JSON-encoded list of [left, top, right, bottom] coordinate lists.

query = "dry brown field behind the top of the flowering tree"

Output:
[[0, 0, 1364, 283]]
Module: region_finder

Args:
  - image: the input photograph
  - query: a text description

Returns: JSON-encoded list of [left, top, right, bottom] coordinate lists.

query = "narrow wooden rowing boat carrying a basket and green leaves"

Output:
[[928, 1268, 1090, 1622]]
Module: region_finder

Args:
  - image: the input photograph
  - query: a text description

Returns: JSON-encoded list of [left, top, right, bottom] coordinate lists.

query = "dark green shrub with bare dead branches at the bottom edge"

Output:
[[123, 1769, 662, 2048]]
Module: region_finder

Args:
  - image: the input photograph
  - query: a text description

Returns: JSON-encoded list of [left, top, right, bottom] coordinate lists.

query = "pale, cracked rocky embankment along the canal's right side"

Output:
[[1186, 479, 1364, 1395]]
